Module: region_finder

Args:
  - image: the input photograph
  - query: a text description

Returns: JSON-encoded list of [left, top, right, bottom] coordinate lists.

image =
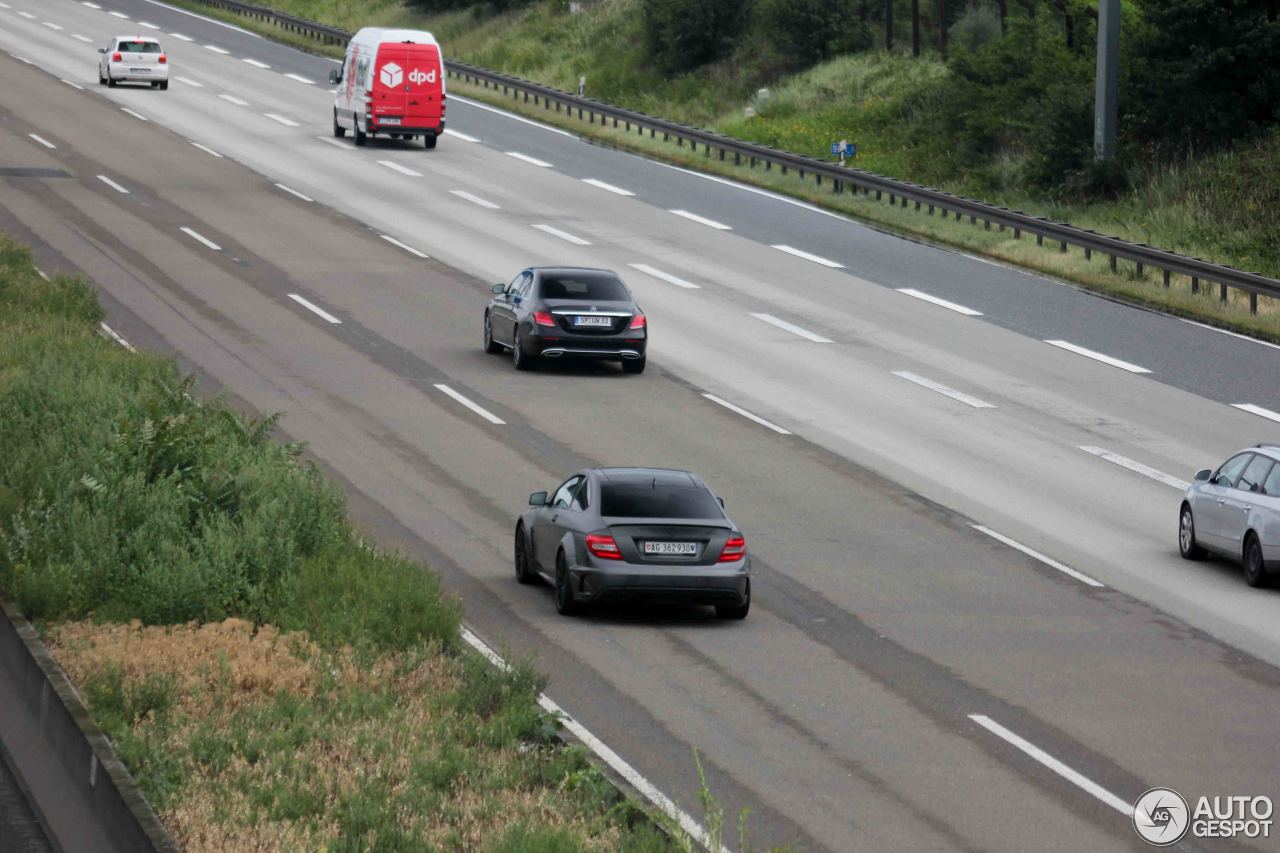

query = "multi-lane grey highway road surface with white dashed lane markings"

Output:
[[0, 0, 1280, 850]]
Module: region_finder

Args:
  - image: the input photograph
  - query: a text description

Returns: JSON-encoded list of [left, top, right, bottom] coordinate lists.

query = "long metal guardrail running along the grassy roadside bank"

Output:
[[192, 0, 1280, 314]]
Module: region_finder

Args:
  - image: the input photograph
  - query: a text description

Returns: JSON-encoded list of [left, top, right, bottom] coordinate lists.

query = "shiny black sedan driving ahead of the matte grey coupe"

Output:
[[484, 266, 649, 373]]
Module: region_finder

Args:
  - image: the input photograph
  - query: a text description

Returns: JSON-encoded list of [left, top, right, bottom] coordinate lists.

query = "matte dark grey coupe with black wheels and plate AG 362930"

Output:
[[515, 467, 751, 619]]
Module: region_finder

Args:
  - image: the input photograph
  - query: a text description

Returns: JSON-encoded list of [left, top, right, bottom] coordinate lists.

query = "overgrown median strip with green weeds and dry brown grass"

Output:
[[0, 234, 687, 852]]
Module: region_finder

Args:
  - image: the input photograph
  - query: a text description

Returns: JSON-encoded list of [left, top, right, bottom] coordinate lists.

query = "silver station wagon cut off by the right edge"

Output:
[[1178, 444, 1280, 587]]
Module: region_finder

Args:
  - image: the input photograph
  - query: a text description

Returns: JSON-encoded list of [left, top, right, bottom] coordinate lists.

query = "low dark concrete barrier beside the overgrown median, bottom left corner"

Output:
[[0, 602, 178, 853]]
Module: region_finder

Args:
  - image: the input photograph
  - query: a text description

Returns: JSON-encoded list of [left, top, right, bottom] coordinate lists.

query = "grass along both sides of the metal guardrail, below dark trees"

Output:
[[167, 0, 1280, 341]]
